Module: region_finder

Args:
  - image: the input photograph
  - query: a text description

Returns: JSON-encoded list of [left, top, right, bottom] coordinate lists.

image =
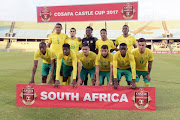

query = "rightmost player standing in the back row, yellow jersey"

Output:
[[115, 25, 137, 52]]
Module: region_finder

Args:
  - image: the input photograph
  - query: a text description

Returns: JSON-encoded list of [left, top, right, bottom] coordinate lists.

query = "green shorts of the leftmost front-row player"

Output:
[[41, 62, 56, 76]]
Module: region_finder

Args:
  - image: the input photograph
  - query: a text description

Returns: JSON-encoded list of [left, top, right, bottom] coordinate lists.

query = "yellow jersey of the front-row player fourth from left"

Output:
[[95, 53, 113, 71]]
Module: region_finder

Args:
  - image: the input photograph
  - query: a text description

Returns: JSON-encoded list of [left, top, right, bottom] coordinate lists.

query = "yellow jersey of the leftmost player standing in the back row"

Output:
[[48, 33, 69, 56]]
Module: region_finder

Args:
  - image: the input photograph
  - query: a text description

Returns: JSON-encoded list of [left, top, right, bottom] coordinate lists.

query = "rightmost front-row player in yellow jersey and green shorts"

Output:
[[132, 38, 154, 87]]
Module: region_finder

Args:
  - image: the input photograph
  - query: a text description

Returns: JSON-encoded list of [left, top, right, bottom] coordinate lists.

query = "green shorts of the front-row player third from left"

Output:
[[80, 67, 95, 80]]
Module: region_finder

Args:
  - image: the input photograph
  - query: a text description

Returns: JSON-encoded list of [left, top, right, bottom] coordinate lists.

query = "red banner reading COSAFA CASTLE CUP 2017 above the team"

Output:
[[37, 2, 138, 22]]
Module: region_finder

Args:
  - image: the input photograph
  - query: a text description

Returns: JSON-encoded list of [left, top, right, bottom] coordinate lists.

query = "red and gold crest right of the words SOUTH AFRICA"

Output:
[[132, 88, 151, 109]]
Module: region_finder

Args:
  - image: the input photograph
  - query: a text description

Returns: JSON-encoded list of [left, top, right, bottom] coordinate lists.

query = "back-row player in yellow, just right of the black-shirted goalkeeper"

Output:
[[96, 29, 116, 53]]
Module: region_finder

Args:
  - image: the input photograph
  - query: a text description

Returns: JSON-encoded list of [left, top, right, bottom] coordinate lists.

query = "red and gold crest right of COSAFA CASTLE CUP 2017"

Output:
[[122, 3, 135, 19]]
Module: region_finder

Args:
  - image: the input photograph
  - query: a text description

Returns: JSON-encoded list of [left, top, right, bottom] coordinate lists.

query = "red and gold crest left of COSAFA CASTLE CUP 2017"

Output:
[[40, 7, 52, 22]]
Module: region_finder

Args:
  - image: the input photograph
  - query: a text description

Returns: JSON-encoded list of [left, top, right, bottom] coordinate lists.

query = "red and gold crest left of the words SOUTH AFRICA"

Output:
[[21, 86, 36, 105]]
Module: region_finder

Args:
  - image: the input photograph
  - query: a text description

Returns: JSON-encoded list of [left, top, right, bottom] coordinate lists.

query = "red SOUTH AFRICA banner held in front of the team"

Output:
[[16, 84, 155, 111]]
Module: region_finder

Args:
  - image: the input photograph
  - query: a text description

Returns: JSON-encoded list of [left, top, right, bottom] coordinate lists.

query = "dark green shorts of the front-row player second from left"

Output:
[[61, 63, 73, 77]]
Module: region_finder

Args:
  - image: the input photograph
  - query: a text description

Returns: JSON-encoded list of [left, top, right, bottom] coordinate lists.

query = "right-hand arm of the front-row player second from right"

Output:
[[129, 54, 136, 89]]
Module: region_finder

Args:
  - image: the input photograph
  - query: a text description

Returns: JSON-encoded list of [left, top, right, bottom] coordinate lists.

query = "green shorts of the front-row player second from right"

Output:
[[117, 68, 132, 81]]
